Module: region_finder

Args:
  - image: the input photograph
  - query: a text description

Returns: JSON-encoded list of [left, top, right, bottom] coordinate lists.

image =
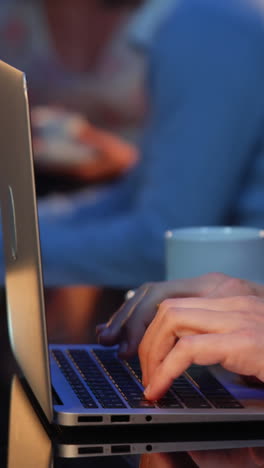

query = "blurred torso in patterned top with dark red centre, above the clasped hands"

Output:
[[0, 0, 145, 127]]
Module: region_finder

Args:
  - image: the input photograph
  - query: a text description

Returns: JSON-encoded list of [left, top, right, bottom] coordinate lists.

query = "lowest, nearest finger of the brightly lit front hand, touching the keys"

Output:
[[145, 334, 237, 400]]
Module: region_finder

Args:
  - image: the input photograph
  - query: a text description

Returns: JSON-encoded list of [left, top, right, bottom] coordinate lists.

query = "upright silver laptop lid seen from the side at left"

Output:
[[0, 61, 53, 421]]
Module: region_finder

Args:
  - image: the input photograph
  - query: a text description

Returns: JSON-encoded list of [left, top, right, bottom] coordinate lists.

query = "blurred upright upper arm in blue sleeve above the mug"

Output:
[[140, 0, 264, 232]]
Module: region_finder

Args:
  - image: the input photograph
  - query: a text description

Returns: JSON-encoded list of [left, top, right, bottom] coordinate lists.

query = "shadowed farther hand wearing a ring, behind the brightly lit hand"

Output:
[[97, 273, 264, 358]]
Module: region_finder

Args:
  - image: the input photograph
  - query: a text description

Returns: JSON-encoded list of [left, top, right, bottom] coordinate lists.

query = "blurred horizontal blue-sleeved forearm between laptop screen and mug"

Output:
[[40, 207, 164, 288]]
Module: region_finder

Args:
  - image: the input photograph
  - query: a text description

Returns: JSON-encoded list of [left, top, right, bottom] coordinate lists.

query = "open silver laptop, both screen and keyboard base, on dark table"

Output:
[[0, 62, 264, 436]]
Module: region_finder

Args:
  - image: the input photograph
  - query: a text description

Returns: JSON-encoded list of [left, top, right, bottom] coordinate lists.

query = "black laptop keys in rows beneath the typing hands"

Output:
[[52, 348, 243, 409]]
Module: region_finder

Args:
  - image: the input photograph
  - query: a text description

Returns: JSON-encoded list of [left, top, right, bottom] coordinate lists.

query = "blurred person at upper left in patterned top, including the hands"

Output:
[[0, 0, 144, 181]]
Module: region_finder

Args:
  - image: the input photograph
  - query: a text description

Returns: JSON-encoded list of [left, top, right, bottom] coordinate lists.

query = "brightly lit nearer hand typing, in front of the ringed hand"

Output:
[[139, 296, 264, 400]]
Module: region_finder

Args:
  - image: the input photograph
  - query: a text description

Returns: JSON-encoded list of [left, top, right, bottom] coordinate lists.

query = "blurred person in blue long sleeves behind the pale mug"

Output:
[[2, 0, 264, 336]]
